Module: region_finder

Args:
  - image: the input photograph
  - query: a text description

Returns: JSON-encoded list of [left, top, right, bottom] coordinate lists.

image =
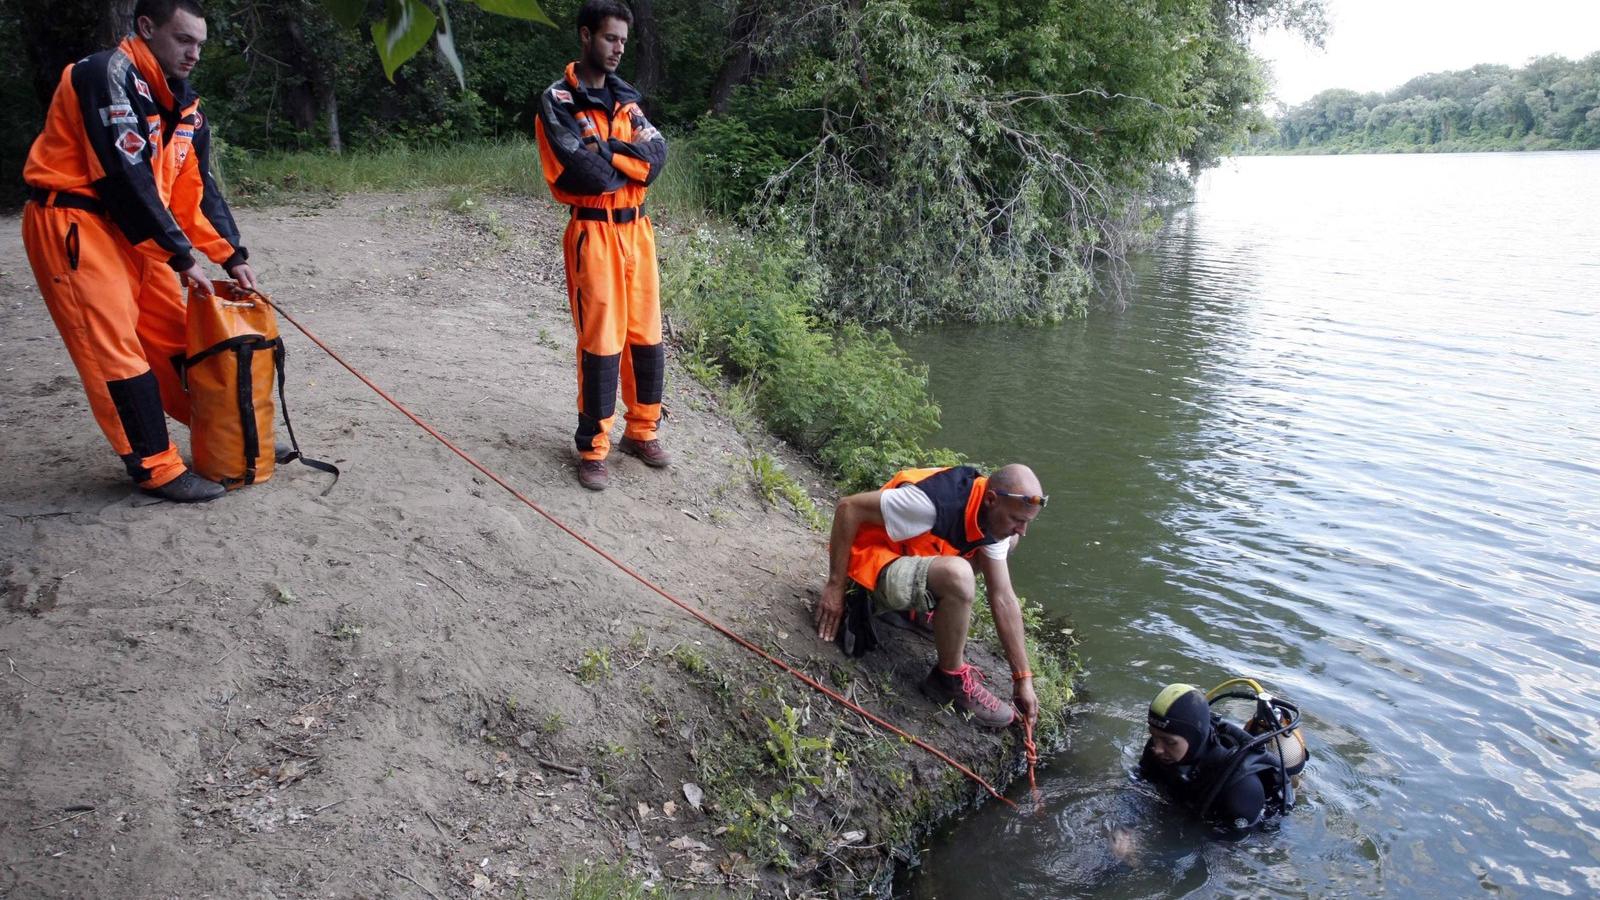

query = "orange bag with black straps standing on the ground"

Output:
[[173, 282, 339, 493]]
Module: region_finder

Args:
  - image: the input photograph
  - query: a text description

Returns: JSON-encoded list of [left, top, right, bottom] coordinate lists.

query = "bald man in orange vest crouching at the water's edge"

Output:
[[814, 464, 1048, 729]]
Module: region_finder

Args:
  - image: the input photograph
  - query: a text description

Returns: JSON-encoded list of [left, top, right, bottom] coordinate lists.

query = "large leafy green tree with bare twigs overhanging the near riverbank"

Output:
[[763, 0, 1286, 325]]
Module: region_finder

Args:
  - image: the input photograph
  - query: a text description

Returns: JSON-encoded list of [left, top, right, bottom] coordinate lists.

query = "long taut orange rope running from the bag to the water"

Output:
[[259, 295, 1011, 809]]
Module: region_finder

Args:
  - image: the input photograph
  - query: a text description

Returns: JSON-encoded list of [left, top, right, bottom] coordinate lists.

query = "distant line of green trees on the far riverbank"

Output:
[[1254, 53, 1600, 152]]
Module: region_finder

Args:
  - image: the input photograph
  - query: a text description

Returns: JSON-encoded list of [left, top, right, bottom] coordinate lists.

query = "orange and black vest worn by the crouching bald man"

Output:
[[850, 466, 995, 591]]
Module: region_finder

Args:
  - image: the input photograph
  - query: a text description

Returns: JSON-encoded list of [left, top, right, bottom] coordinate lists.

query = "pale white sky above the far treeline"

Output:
[[1251, 0, 1600, 106]]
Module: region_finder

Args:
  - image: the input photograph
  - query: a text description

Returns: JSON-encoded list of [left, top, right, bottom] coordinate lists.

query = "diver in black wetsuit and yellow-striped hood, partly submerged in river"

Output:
[[1139, 679, 1307, 836]]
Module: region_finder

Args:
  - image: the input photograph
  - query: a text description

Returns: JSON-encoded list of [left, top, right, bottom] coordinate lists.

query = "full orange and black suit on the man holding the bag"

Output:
[[22, 37, 248, 487]]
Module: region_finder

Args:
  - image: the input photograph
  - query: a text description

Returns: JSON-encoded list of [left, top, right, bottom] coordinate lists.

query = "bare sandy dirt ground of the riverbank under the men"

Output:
[[0, 195, 1024, 898]]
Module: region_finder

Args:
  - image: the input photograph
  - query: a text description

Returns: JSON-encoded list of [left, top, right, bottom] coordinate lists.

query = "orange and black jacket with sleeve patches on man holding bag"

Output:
[[22, 37, 250, 271]]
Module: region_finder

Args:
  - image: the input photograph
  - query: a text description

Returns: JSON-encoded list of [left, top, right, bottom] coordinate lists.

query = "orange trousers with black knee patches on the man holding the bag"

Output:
[[22, 200, 189, 488]]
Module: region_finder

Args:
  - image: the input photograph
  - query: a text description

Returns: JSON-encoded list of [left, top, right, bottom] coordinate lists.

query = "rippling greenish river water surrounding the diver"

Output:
[[901, 152, 1600, 900]]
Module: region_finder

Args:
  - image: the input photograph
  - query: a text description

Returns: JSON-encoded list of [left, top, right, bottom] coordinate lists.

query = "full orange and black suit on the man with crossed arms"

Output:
[[534, 62, 667, 460]]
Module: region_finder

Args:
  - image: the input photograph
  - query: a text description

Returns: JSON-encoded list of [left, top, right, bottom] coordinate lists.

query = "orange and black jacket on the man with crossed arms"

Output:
[[533, 62, 667, 210]]
